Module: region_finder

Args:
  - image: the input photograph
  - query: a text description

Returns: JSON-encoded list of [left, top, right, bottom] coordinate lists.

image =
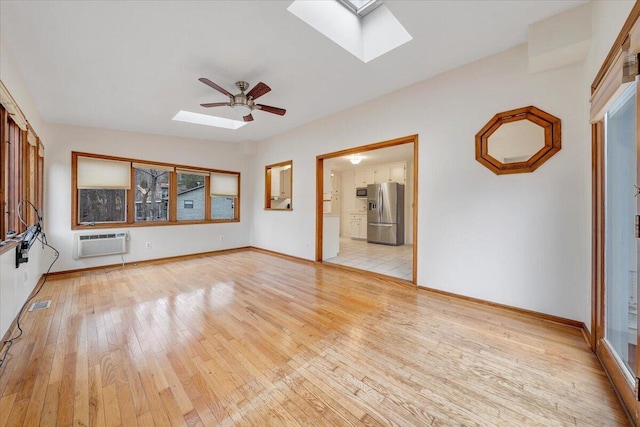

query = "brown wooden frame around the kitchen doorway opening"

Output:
[[315, 134, 418, 285]]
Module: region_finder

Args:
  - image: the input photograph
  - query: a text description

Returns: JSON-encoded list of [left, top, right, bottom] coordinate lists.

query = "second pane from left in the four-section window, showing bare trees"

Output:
[[135, 168, 170, 222]]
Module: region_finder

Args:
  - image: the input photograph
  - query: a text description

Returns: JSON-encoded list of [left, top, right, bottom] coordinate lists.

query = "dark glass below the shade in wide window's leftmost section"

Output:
[[78, 189, 127, 224]]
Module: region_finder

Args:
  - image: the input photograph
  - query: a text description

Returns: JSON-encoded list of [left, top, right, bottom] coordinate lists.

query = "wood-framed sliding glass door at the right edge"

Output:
[[592, 80, 640, 422]]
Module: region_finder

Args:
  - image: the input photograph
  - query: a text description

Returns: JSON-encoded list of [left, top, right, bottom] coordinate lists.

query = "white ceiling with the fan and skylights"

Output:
[[0, 0, 584, 145]]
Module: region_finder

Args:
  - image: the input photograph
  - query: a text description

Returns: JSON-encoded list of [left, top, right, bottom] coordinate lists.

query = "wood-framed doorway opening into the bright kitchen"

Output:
[[316, 135, 418, 285]]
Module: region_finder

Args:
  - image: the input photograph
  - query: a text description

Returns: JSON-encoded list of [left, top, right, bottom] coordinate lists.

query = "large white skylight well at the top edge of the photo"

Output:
[[287, 0, 413, 62]]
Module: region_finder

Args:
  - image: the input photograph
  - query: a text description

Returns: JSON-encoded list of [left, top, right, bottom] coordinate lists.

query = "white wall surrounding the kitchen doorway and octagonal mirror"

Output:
[[248, 0, 628, 325]]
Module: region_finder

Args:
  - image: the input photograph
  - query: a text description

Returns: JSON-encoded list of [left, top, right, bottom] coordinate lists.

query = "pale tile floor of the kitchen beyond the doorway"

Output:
[[323, 237, 413, 280]]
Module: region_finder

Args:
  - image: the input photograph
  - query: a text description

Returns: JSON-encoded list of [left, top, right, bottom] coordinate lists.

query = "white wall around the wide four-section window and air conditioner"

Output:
[[45, 124, 255, 271]]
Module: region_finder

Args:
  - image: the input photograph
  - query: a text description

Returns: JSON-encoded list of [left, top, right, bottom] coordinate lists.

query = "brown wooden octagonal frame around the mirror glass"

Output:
[[476, 106, 561, 175]]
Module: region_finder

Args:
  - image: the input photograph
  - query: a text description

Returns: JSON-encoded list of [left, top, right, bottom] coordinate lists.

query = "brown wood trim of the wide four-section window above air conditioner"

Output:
[[71, 151, 241, 230]]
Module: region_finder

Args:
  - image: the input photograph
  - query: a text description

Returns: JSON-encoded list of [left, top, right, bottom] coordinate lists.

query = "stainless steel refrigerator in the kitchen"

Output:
[[367, 182, 404, 246]]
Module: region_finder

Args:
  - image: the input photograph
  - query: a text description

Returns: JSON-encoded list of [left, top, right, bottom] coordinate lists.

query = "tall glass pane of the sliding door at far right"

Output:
[[604, 83, 640, 384]]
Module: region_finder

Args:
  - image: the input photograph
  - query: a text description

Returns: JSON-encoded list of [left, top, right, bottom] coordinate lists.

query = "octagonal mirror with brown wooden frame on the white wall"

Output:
[[476, 106, 561, 175]]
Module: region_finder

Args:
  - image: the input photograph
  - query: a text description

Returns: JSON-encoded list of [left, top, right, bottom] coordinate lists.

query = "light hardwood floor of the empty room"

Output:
[[0, 251, 627, 426]]
